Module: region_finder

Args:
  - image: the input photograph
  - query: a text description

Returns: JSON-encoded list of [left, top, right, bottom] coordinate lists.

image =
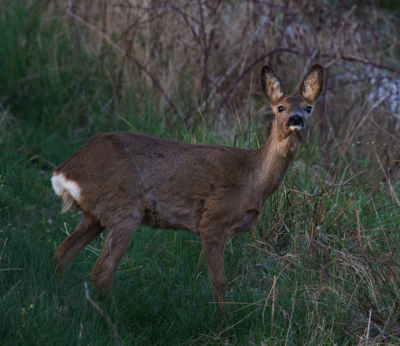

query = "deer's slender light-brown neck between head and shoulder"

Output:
[[258, 124, 300, 202]]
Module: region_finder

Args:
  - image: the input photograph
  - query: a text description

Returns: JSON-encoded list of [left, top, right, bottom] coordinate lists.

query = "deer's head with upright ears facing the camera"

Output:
[[261, 65, 323, 156]]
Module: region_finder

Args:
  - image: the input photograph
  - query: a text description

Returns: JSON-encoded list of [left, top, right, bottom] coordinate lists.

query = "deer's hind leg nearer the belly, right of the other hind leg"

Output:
[[91, 215, 142, 296]]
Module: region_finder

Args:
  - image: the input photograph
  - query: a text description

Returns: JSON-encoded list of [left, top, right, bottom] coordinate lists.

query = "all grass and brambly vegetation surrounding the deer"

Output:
[[0, 0, 400, 346]]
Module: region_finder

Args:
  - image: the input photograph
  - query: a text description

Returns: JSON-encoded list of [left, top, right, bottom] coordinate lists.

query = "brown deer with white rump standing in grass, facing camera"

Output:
[[51, 65, 323, 315]]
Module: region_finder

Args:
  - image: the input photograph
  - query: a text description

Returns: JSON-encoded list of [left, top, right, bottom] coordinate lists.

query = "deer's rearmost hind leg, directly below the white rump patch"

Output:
[[53, 213, 104, 274]]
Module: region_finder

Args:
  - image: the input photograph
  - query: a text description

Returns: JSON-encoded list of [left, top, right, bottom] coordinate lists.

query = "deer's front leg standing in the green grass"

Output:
[[200, 230, 227, 317]]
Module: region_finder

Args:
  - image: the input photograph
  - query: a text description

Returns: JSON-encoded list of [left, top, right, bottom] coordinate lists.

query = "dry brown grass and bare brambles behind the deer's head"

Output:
[[53, 0, 399, 121]]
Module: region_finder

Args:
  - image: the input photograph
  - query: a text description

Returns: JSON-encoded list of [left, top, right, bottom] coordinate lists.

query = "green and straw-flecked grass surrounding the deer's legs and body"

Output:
[[0, 1, 400, 346]]
